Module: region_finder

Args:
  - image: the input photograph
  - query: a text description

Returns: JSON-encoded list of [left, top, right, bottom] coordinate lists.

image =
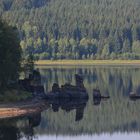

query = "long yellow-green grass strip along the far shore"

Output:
[[35, 60, 140, 66]]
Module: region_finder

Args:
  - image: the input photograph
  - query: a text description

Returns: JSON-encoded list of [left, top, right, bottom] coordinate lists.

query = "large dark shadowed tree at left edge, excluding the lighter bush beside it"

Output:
[[0, 21, 21, 87]]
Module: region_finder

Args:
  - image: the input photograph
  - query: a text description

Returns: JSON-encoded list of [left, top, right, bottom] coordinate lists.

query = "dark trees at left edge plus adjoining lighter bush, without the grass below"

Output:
[[0, 19, 34, 90]]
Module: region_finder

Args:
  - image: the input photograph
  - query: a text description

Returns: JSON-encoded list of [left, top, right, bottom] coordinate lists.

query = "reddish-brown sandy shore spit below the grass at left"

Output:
[[0, 98, 49, 119]]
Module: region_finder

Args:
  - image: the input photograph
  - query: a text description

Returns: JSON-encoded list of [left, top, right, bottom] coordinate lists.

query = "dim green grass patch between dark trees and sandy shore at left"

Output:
[[0, 89, 32, 103]]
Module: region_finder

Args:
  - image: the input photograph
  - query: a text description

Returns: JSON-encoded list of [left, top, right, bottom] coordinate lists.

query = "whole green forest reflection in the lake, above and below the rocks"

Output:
[[34, 67, 140, 134]]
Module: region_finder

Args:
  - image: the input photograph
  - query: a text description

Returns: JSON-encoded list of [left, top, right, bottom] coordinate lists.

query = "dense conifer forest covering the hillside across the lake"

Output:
[[0, 0, 140, 59]]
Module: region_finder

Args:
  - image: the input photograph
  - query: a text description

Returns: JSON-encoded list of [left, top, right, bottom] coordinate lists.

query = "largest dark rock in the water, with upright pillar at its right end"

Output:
[[46, 75, 88, 99]]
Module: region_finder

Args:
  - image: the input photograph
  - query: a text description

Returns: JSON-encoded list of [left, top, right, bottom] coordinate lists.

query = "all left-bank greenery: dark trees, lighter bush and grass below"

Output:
[[0, 20, 34, 100]]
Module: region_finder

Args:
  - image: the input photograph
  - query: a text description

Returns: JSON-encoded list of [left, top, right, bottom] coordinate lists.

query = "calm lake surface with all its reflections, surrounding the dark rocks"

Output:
[[0, 66, 140, 140]]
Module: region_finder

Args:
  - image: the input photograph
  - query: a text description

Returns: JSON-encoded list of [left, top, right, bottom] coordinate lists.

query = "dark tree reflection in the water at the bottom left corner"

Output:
[[0, 114, 41, 140]]
